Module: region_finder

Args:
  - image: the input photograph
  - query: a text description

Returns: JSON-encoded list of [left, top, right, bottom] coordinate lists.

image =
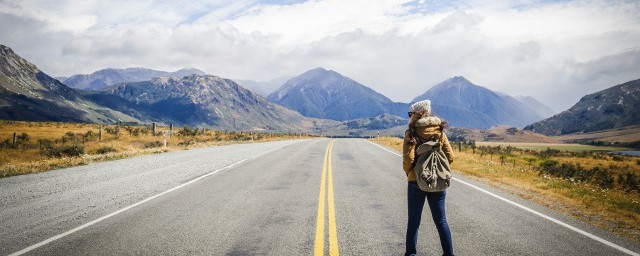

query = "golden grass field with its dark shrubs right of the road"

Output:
[[371, 138, 640, 242]]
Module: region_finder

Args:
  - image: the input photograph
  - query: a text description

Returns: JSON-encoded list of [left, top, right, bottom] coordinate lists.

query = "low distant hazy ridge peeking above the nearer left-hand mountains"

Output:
[[60, 68, 205, 91]]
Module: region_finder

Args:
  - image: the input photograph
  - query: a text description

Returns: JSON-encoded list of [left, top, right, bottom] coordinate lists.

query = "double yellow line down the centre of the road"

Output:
[[313, 140, 340, 256]]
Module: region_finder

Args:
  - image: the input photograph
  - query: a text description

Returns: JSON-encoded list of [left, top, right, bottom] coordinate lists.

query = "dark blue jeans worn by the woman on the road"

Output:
[[405, 181, 453, 255]]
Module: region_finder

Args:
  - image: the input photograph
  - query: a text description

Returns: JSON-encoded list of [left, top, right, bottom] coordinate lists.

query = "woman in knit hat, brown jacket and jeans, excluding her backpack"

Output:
[[402, 100, 454, 255]]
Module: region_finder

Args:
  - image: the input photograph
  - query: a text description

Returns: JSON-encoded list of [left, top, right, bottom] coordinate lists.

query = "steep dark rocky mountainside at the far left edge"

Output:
[[0, 45, 138, 123]]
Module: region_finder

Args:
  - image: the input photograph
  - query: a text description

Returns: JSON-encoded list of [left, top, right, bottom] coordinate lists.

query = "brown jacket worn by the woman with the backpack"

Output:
[[402, 117, 455, 181]]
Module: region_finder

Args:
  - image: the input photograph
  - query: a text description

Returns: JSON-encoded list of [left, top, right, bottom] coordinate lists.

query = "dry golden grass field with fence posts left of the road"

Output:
[[0, 121, 310, 177]]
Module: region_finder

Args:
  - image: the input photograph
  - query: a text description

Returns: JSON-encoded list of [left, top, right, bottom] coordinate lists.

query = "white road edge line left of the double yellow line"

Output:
[[9, 141, 299, 256]]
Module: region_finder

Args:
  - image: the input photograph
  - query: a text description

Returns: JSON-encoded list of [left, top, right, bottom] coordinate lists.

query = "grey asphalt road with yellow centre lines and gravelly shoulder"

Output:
[[0, 139, 640, 255]]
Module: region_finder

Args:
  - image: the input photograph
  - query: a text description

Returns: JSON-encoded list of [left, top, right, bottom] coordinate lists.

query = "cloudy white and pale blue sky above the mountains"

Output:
[[0, 0, 640, 112]]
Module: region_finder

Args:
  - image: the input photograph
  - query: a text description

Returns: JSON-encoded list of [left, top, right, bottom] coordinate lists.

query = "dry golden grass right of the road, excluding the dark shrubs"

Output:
[[371, 138, 640, 242]]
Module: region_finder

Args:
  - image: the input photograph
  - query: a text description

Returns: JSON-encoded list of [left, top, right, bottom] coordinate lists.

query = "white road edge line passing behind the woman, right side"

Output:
[[365, 140, 640, 256]]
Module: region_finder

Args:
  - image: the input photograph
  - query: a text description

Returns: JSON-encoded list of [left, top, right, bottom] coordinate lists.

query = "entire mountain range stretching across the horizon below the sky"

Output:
[[0, 46, 640, 136]]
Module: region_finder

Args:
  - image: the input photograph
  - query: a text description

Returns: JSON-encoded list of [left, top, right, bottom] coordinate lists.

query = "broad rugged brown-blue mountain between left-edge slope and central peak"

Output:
[[87, 75, 324, 131]]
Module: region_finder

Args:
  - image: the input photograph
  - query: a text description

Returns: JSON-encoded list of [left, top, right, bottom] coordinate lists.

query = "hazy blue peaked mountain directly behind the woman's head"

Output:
[[413, 76, 544, 129]]
